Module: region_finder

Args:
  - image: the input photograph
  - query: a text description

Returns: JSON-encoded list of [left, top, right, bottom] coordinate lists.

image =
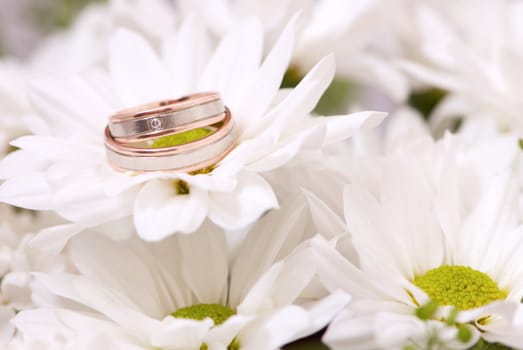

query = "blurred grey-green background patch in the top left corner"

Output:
[[0, 0, 106, 59]]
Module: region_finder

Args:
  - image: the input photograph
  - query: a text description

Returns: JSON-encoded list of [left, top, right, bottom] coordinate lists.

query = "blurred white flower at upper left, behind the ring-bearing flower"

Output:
[[0, 5, 110, 156]]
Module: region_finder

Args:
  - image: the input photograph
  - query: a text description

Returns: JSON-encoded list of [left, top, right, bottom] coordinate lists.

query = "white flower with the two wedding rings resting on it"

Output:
[[0, 20, 385, 241]]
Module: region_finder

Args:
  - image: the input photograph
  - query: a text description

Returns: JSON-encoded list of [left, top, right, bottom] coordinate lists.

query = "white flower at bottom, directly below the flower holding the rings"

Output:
[[14, 202, 349, 350]]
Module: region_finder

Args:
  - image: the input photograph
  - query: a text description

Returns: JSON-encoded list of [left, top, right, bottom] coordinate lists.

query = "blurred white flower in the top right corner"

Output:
[[402, 0, 523, 135]]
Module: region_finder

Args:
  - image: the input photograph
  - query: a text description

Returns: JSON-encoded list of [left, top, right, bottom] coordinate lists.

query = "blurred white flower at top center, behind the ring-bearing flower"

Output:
[[178, 0, 408, 100]]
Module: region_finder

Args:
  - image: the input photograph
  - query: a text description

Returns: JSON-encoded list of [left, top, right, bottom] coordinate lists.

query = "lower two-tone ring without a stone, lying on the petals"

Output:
[[105, 107, 234, 172]]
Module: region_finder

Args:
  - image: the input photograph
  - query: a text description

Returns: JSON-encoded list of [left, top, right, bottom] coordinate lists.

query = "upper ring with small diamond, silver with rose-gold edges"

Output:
[[108, 92, 225, 143]]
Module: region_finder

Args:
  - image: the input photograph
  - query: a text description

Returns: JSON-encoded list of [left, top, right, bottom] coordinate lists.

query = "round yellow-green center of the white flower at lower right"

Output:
[[414, 265, 507, 310]]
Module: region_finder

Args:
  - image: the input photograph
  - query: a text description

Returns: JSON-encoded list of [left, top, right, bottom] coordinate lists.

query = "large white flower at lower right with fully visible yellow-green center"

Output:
[[313, 136, 523, 349]]
